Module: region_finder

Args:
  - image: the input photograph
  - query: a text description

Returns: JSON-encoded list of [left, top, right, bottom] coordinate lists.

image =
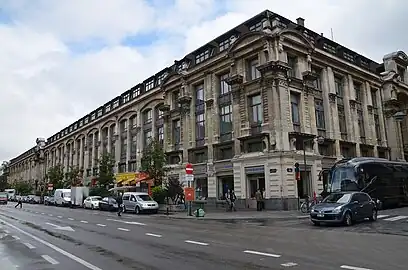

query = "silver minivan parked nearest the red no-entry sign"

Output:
[[122, 192, 159, 214]]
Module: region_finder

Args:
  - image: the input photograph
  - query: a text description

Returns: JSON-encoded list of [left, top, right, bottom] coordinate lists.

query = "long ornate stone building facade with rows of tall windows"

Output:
[[10, 11, 408, 209]]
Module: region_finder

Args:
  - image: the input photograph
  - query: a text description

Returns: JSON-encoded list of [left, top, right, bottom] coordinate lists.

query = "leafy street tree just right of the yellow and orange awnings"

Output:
[[141, 140, 169, 186]]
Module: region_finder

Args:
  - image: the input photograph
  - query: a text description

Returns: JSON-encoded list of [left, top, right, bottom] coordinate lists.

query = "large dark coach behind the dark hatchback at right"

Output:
[[320, 157, 408, 207]]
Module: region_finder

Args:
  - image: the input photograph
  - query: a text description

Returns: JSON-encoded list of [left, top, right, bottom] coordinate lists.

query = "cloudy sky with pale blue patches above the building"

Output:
[[0, 0, 408, 161]]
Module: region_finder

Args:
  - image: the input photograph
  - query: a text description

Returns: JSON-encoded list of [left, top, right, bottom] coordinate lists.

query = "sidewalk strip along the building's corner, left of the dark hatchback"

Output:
[[160, 211, 309, 223]]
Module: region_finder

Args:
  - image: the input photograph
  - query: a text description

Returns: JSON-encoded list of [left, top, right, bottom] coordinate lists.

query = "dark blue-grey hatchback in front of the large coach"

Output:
[[310, 192, 378, 226]]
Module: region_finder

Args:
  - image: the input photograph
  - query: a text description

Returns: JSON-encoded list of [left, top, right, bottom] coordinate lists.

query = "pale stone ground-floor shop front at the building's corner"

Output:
[[174, 152, 336, 210]]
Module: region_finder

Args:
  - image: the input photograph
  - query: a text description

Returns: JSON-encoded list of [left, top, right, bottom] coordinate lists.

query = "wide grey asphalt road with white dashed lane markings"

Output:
[[0, 205, 408, 270]]
